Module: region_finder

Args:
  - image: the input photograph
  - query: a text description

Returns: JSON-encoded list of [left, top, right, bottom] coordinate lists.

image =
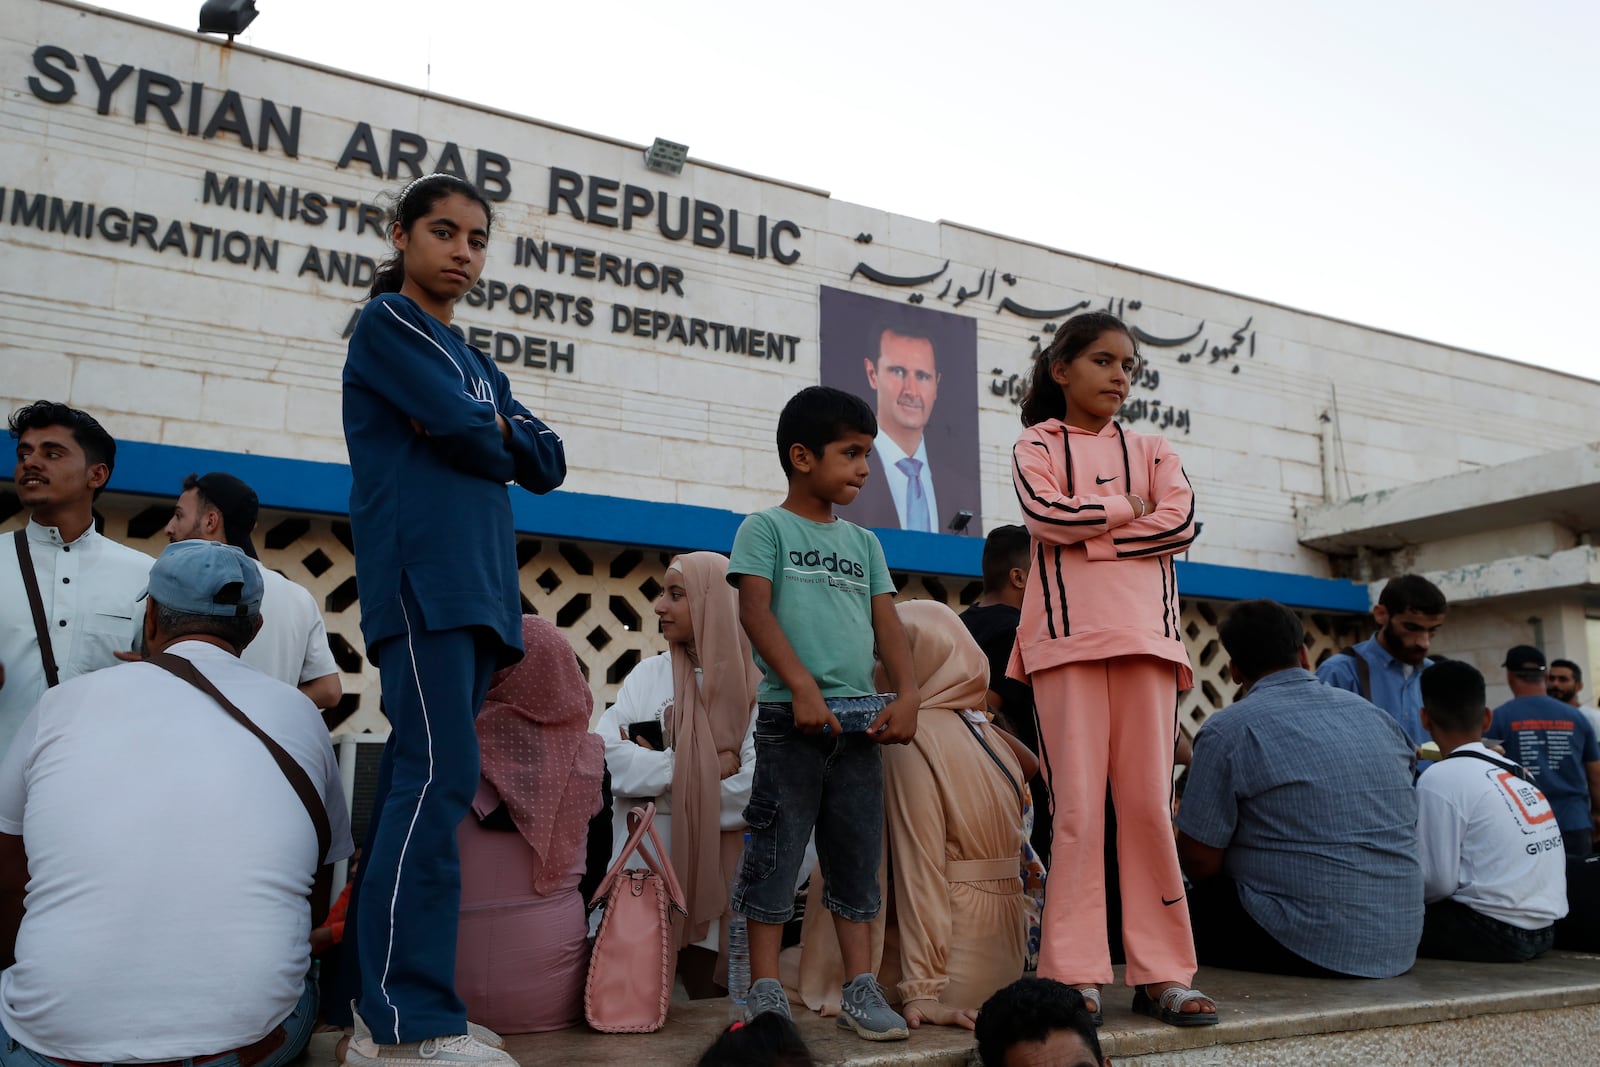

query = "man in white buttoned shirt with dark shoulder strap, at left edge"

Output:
[[0, 400, 152, 755]]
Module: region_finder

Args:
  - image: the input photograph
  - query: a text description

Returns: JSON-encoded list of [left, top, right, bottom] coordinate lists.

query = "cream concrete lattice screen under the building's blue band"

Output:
[[0, 493, 1366, 734]]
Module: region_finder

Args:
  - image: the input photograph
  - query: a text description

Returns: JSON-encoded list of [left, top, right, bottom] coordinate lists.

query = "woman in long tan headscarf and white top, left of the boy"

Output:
[[595, 552, 760, 997]]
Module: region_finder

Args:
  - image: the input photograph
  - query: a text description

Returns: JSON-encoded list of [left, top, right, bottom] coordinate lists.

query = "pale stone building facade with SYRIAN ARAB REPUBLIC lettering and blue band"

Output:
[[0, 0, 1600, 729]]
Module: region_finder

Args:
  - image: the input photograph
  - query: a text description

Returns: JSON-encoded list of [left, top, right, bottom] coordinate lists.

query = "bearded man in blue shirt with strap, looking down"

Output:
[[1317, 574, 1446, 747]]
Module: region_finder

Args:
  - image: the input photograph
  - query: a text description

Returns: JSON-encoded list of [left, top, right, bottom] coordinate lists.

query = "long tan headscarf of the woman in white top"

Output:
[[667, 552, 762, 947]]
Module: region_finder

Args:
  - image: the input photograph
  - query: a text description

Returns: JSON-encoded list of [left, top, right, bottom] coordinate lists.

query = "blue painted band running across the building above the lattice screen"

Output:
[[6, 442, 1370, 614]]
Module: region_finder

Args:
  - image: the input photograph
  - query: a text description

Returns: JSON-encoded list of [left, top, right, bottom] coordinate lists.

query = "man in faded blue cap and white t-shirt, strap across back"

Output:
[[0, 541, 352, 1067]]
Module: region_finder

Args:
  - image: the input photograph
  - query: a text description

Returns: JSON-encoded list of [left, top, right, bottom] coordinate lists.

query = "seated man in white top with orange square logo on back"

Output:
[[1416, 661, 1566, 963]]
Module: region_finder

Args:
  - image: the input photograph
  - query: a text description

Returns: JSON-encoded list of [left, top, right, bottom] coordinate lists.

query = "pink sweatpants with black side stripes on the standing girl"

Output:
[[1032, 656, 1195, 985]]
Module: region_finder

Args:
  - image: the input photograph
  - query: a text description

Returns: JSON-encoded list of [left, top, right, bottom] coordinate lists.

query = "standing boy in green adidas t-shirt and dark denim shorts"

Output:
[[728, 386, 922, 1041]]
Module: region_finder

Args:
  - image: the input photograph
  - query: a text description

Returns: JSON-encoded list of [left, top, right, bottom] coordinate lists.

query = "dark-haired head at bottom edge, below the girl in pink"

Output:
[[978, 977, 1110, 1067]]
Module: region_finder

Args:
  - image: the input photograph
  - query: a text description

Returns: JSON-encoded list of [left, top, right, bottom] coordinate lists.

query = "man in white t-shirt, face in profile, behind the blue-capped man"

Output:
[[166, 472, 342, 707]]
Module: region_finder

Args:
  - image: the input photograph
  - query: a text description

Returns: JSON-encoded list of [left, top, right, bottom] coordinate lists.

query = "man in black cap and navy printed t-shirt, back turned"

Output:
[[1483, 645, 1600, 859]]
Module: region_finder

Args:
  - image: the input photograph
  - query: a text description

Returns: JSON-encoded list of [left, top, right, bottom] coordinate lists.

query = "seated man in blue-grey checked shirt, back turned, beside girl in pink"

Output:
[[1178, 600, 1422, 977]]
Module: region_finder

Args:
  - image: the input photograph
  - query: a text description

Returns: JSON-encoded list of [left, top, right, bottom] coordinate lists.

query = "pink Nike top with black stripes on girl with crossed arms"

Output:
[[1008, 419, 1197, 689]]
